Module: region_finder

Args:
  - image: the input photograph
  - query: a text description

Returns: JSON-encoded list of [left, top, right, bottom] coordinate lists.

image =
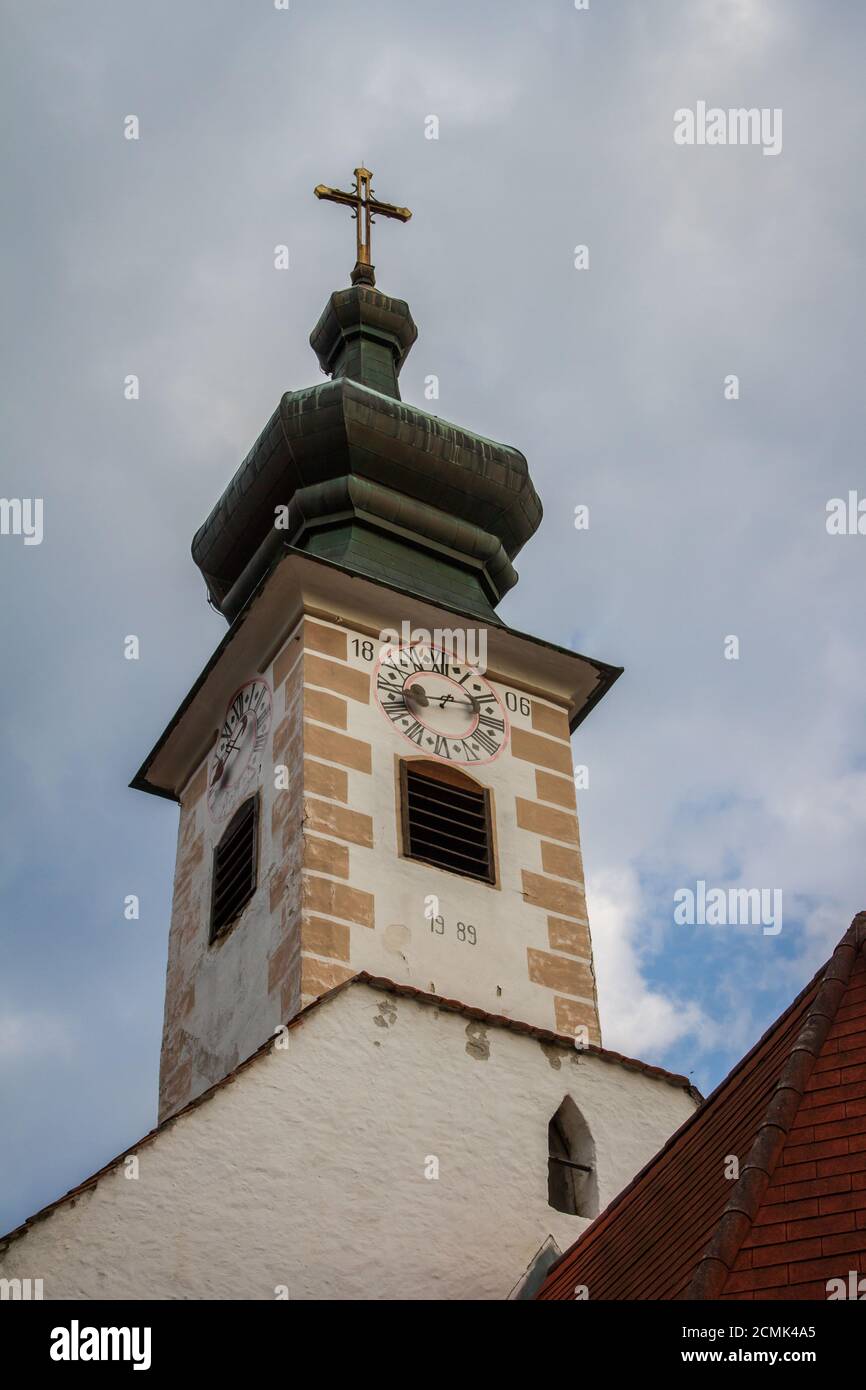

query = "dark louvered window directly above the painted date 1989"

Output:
[[400, 763, 496, 883]]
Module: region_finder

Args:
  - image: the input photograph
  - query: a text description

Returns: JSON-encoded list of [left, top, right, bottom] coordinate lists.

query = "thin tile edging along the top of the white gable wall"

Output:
[[0, 970, 702, 1255]]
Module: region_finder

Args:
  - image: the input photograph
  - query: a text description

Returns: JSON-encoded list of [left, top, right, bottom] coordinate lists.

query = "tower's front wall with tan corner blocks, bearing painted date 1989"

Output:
[[287, 620, 599, 1041]]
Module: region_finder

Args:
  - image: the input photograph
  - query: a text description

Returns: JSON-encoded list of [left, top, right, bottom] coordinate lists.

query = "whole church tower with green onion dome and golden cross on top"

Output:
[[132, 168, 620, 1120]]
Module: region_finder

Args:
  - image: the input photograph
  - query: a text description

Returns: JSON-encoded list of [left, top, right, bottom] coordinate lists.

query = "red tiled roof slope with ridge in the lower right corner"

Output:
[[538, 912, 866, 1301]]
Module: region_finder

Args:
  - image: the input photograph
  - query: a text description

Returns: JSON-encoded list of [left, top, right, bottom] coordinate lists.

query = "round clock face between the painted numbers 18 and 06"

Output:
[[375, 642, 509, 763]]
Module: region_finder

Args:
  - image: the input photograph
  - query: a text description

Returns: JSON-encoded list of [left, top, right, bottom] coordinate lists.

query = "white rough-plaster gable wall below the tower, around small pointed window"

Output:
[[0, 984, 694, 1300]]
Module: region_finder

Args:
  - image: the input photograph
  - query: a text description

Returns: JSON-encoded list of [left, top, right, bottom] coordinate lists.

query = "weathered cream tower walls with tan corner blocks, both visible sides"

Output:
[[160, 603, 601, 1118]]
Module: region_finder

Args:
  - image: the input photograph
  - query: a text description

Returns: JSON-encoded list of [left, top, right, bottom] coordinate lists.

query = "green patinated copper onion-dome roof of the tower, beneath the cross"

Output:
[[192, 285, 541, 620]]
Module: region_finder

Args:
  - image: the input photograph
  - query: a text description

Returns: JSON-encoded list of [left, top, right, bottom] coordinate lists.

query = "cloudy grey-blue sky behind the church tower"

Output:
[[0, 0, 866, 1229]]
